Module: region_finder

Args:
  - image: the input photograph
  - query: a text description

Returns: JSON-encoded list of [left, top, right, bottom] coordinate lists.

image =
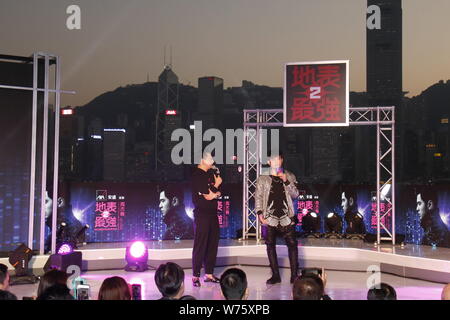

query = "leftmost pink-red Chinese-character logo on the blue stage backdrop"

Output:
[[94, 190, 125, 231]]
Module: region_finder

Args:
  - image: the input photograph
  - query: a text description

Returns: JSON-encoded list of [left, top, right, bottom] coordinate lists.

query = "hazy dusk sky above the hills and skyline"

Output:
[[0, 0, 450, 105]]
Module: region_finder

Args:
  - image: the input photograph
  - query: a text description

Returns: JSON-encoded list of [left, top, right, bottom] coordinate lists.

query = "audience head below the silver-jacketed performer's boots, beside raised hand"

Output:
[[292, 274, 325, 300]]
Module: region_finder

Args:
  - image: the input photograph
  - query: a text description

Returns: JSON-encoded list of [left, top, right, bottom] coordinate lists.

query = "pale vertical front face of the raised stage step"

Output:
[[0, 244, 450, 283]]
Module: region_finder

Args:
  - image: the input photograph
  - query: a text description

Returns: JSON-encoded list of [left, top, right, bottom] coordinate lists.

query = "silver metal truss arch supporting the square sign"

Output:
[[242, 107, 395, 244]]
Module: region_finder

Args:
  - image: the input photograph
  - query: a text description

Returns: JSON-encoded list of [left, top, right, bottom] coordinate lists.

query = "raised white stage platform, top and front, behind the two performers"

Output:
[[0, 239, 450, 283]]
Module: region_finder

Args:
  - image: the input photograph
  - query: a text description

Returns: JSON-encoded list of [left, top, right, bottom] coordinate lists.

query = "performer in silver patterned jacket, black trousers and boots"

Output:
[[255, 152, 298, 284]]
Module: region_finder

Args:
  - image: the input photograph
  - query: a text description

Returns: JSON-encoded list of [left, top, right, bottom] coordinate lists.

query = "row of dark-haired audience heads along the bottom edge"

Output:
[[0, 262, 450, 300]]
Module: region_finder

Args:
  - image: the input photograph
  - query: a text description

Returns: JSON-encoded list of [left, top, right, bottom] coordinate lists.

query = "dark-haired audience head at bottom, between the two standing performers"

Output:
[[220, 268, 248, 300]]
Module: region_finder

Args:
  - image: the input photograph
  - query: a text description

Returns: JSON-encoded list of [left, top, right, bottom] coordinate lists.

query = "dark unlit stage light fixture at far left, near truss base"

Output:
[[8, 243, 38, 285]]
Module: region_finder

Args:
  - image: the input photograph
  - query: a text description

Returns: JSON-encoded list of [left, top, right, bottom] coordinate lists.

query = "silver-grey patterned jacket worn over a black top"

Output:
[[255, 170, 298, 227]]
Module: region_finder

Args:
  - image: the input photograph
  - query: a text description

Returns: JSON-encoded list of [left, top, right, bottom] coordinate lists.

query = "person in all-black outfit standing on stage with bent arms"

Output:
[[192, 153, 222, 287]]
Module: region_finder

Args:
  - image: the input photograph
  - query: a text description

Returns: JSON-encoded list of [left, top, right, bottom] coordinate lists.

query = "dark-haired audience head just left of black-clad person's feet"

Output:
[[155, 262, 184, 299]]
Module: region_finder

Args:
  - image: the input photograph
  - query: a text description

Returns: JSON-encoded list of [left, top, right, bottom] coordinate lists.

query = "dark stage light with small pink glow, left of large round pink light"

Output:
[[44, 242, 83, 272]]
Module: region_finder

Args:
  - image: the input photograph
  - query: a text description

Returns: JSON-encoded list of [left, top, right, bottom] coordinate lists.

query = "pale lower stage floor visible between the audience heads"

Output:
[[10, 266, 443, 300]]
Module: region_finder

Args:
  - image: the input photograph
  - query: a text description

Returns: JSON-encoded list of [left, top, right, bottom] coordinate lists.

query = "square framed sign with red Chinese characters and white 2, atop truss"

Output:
[[283, 60, 349, 127]]
